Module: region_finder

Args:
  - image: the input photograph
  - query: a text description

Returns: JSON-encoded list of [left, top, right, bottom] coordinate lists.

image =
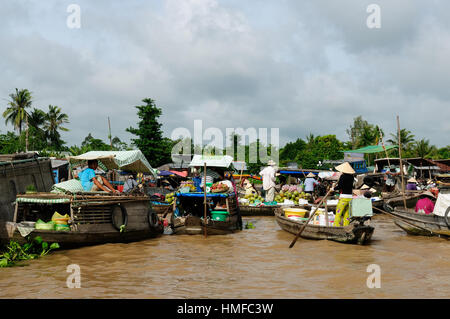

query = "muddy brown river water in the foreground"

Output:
[[0, 216, 450, 298]]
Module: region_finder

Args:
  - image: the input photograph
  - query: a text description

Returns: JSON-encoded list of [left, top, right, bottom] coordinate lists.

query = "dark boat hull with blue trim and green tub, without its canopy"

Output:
[[171, 193, 242, 235]]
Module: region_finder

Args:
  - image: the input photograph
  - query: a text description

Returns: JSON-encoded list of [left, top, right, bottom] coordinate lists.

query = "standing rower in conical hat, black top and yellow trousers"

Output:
[[331, 162, 355, 227]]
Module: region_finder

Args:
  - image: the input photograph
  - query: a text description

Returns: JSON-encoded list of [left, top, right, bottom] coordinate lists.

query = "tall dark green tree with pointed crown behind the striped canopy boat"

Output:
[[126, 98, 172, 167]]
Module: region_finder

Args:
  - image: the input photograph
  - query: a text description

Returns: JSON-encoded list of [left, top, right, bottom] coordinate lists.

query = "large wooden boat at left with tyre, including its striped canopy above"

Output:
[[2, 150, 164, 248]]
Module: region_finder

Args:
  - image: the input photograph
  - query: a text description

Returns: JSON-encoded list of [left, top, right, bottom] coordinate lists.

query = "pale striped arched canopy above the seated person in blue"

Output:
[[67, 150, 157, 177]]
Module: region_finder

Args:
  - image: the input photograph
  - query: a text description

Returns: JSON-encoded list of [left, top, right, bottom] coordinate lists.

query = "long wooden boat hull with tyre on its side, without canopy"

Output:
[[1, 192, 164, 248]]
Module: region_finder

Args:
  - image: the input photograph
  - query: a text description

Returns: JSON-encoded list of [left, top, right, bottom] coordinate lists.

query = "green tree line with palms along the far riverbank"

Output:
[[0, 89, 450, 173]]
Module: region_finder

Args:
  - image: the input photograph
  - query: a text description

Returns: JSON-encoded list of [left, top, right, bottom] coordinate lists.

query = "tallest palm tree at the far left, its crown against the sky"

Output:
[[3, 88, 32, 135]]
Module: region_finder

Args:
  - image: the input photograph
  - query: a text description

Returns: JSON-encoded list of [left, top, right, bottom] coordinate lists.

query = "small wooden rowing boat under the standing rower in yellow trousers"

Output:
[[275, 208, 374, 245]]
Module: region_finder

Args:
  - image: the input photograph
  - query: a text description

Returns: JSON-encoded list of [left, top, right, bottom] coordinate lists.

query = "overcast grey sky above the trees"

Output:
[[0, 0, 450, 147]]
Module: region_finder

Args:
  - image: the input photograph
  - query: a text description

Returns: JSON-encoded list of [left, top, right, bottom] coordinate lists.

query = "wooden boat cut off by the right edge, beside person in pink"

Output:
[[384, 190, 450, 237]]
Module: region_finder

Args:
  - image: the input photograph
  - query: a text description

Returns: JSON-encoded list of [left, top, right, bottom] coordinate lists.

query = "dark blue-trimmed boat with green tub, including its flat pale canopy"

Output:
[[170, 155, 242, 235]]
